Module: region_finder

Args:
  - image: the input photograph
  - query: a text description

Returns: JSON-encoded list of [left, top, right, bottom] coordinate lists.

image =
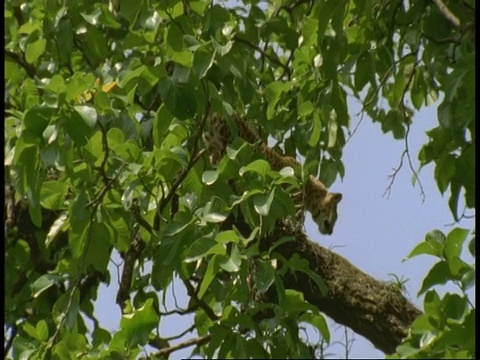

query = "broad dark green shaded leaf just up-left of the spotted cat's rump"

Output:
[[158, 78, 197, 120]]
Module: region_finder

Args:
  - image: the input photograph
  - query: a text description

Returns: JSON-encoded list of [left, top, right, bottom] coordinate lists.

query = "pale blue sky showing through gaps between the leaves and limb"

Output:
[[92, 95, 475, 359]]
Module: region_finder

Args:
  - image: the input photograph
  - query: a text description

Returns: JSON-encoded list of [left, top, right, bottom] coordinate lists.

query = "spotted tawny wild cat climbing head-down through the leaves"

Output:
[[202, 113, 342, 235]]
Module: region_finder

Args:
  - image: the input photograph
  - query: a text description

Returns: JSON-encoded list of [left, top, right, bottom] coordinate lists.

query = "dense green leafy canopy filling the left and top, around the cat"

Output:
[[5, 0, 475, 359]]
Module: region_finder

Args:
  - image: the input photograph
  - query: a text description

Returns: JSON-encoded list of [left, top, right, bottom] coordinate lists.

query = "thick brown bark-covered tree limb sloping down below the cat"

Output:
[[267, 231, 421, 354]]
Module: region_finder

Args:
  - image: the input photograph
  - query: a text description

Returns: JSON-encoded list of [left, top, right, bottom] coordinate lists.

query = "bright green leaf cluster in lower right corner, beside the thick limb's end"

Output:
[[389, 228, 475, 359]]
